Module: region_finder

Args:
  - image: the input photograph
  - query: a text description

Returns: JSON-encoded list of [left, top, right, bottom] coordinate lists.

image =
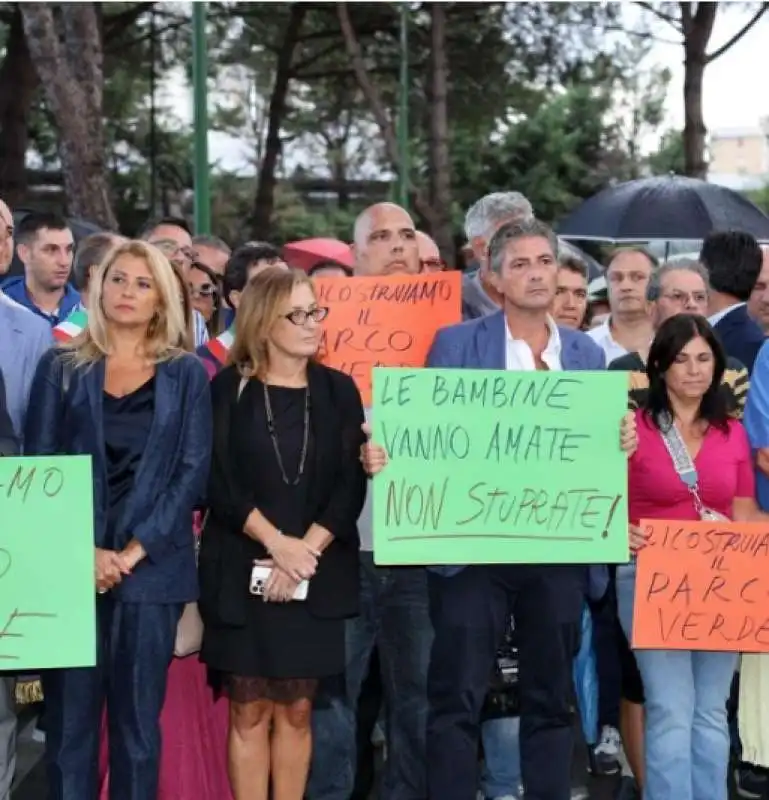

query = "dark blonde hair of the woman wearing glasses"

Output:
[[229, 267, 315, 378]]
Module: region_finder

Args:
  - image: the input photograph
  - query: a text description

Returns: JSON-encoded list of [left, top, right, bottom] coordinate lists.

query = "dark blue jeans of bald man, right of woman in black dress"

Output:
[[306, 552, 433, 800]]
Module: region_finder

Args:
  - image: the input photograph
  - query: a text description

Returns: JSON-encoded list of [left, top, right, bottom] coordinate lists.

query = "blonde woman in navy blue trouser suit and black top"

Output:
[[25, 241, 211, 800]]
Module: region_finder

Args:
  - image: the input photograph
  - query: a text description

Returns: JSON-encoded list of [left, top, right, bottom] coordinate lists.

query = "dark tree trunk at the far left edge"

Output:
[[0, 6, 38, 203]]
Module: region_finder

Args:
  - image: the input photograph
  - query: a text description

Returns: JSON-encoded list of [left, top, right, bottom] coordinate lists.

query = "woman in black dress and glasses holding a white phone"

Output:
[[200, 268, 366, 800]]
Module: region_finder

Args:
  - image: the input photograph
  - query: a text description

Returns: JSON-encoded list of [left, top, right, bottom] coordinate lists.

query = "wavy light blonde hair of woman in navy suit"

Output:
[[67, 239, 187, 364]]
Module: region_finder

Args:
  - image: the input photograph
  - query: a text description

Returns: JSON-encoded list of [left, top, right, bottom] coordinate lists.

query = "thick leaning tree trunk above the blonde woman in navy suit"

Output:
[[20, 3, 117, 230]]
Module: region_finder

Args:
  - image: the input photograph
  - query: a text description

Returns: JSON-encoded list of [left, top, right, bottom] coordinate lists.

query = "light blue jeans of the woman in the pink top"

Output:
[[617, 564, 737, 800]]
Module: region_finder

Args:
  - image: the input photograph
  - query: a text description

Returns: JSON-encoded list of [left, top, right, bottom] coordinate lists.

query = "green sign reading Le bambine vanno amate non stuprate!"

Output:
[[372, 369, 628, 564]]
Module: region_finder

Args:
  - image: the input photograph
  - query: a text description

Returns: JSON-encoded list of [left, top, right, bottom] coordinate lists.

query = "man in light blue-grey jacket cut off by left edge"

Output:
[[0, 195, 53, 800]]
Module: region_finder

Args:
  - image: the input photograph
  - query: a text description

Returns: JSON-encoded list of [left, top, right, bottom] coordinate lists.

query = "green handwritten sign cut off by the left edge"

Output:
[[0, 456, 96, 672]]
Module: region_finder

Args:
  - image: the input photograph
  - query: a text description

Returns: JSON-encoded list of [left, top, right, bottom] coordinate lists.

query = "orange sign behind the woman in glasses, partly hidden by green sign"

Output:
[[315, 272, 462, 408]]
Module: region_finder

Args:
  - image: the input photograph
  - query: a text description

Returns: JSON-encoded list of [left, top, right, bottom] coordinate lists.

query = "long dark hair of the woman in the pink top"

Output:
[[644, 314, 729, 431]]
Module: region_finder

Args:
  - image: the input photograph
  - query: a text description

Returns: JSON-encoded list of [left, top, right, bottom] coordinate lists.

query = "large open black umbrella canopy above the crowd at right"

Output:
[[558, 175, 769, 242]]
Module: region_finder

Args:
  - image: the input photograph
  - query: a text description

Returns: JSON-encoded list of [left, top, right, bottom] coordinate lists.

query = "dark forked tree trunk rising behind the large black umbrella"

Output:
[[679, 2, 718, 179]]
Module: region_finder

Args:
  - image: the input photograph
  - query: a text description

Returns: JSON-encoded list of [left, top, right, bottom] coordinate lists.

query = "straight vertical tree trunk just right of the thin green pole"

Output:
[[429, 3, 456, 265]]
